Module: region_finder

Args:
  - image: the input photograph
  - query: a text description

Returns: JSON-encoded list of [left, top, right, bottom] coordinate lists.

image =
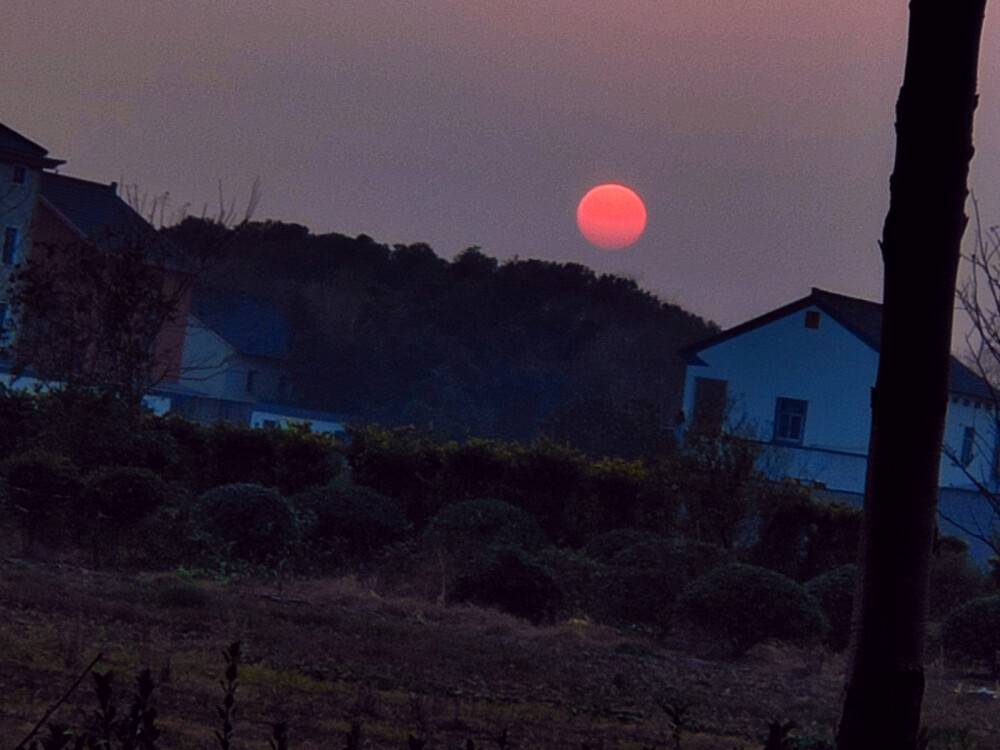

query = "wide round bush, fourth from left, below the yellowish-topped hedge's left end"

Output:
[[292, 487, 406, 555]]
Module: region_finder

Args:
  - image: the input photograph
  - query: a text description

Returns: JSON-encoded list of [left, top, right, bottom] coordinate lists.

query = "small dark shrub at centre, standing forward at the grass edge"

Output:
[[451, 547, 563, 624]]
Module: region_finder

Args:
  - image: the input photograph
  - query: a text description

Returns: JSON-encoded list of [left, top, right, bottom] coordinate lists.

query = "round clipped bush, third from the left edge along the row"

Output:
[[201, 484, 298, 563]]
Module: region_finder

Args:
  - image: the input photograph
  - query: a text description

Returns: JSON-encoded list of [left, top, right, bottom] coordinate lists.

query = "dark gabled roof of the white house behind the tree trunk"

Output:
[[681, 287, 992, 399]]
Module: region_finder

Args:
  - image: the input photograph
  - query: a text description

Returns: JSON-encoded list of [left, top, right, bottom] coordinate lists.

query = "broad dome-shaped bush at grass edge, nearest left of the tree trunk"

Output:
[[678, 563, 827, 653]]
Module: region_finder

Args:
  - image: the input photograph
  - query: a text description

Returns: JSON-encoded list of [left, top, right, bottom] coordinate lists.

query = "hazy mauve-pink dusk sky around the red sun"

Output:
[[0, 0, 1000, 326]]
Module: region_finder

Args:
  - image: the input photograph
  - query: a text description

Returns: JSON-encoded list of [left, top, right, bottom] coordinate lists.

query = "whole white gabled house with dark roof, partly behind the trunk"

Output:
[[682, 288, 997, 557]]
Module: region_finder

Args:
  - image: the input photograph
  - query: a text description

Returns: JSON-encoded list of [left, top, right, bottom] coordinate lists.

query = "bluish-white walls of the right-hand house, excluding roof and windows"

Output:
[[684, 307, 995, 493]]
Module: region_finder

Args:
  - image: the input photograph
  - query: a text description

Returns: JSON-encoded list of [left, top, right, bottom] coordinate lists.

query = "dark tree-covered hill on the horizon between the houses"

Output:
[[167, 214, 715, 456]]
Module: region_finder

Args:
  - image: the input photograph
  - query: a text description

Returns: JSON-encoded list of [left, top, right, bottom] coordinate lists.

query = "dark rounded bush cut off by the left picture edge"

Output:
[[0, 450, 83, 547]]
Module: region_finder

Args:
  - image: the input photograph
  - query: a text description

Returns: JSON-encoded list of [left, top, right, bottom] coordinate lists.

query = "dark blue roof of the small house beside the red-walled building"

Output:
[[194, 291, 291, 359]]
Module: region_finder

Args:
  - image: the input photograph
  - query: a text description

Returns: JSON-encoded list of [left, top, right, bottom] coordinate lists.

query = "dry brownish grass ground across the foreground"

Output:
[[0, 560, 1000, 750]]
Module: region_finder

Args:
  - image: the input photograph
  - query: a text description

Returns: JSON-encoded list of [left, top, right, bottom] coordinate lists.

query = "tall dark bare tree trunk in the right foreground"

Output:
[[837, 0, 986, 750]]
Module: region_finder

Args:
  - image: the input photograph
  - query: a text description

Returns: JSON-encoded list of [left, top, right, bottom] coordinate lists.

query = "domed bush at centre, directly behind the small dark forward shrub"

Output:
[[424, 499, 548, 556]]
